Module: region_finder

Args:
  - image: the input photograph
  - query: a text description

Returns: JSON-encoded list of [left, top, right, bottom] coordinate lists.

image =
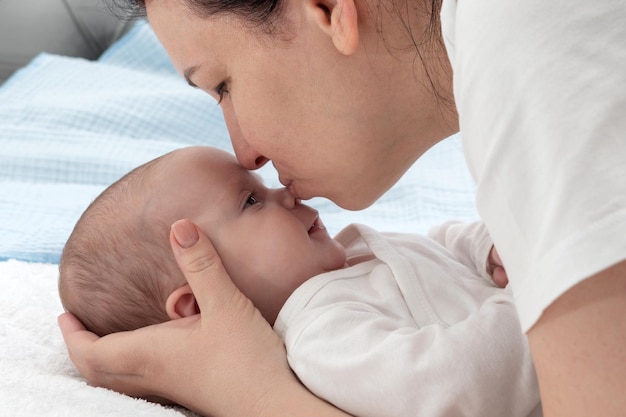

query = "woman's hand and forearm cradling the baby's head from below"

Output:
[[59, 220, 346, 417]]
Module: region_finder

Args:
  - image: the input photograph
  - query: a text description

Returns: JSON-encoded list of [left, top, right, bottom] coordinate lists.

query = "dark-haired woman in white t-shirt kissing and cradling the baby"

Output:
[[60, 0, 626, 417]]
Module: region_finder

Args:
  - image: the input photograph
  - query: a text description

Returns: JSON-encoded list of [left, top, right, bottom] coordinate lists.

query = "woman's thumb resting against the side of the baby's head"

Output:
[[170, 219, 239, 311]]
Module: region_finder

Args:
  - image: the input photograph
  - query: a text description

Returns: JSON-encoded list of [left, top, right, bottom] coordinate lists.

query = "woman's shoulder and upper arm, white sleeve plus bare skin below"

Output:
[[444, 0, 626, 417]]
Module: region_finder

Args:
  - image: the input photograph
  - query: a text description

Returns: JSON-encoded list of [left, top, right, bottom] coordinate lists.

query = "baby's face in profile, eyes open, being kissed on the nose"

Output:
[[151, 147, 346, 324]]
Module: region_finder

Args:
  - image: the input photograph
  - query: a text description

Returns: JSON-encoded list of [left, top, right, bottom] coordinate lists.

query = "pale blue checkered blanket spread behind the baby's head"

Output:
[[0, 23, 476, 263]]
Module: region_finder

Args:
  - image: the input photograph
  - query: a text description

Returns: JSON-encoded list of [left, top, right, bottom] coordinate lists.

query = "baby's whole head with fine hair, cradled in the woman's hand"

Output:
[[59, 147, 345, 335]]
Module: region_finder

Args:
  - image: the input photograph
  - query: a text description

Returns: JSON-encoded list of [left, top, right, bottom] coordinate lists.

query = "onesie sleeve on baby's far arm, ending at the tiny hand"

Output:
[[428, 220, 493, 284]]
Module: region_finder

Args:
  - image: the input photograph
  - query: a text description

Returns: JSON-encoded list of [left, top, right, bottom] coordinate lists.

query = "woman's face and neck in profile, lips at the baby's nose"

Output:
[[146, 0, 456, 209]]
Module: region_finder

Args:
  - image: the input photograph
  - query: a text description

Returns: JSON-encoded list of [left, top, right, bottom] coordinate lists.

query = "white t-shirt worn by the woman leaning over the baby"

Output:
[[441, 0, 626, 331]]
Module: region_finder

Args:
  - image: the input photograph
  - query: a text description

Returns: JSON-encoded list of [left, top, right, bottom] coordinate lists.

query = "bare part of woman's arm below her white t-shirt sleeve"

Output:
[[528, 262, 626, 417]]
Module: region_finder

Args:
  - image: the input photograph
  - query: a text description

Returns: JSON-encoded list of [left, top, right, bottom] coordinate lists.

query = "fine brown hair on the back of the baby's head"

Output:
[[59, 155, 186, 336]]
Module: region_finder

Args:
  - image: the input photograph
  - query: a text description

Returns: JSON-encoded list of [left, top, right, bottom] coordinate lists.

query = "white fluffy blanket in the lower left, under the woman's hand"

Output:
[[0, 260, 193, 417]]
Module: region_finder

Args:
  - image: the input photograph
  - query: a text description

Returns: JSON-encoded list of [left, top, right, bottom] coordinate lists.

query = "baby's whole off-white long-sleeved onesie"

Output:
[[274, 223, 542, 417]]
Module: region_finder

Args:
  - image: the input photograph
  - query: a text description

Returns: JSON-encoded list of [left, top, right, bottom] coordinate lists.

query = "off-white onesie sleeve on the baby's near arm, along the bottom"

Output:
[[282, 290, 539, 417]]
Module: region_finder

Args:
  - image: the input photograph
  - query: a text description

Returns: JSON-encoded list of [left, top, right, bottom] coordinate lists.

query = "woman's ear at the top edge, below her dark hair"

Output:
[[306, 0, 359, 55]]
